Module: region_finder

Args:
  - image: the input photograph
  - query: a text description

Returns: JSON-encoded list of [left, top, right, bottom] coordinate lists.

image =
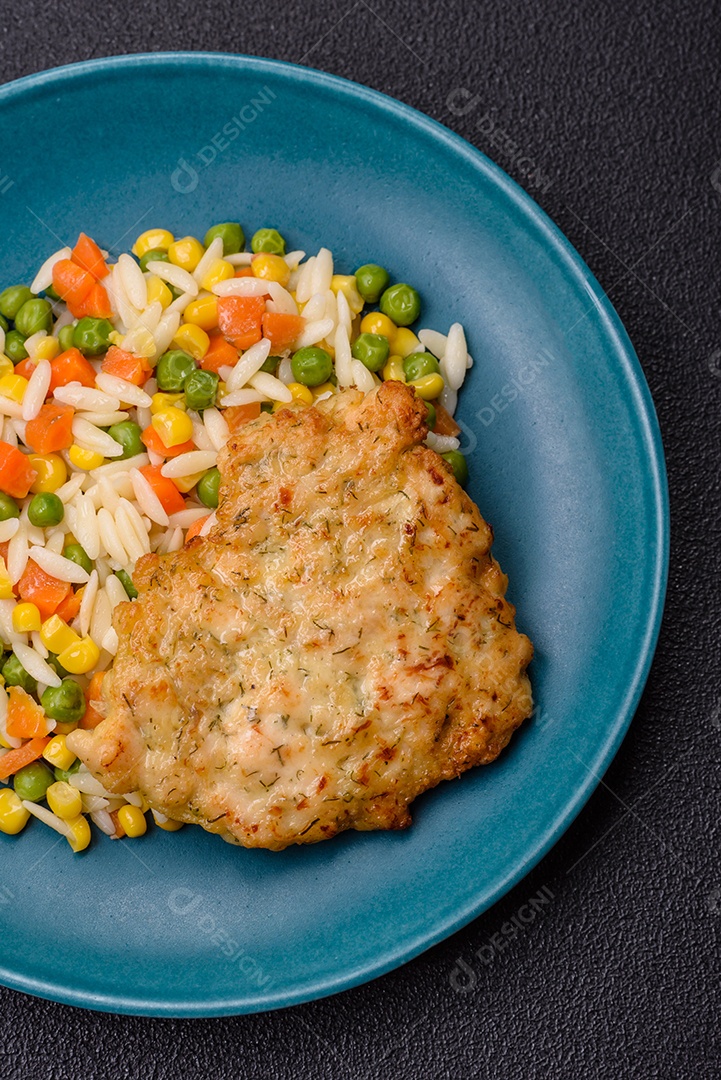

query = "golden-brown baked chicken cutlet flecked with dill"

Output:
[[67, 381, 531, 849]]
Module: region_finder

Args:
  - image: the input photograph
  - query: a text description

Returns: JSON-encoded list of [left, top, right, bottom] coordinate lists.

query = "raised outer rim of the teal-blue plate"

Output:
[[0, 51, 670, 1017]]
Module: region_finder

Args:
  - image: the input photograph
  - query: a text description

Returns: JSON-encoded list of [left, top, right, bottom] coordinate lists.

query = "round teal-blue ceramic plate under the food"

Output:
[[0, 54, 668, 1015]]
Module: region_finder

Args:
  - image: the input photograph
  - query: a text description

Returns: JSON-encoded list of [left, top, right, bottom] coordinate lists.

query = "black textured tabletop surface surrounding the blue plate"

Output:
[[0, 0, 721, 1080]]
